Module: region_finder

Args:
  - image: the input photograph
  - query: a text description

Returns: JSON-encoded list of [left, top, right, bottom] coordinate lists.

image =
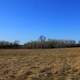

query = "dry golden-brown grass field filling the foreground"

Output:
[[0, 48, 80, 80]]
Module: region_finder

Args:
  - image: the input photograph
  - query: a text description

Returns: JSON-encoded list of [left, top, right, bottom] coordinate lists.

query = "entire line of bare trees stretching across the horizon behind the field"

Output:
[[0, 36, 80, 49]]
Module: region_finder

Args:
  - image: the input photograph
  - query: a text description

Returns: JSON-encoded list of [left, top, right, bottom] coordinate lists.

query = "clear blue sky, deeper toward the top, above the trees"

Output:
[[0, 0, 80, 42]]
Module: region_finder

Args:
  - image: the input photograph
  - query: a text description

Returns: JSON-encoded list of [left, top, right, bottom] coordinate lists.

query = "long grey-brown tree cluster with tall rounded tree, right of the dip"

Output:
[[24, 36, 80, 49]]
